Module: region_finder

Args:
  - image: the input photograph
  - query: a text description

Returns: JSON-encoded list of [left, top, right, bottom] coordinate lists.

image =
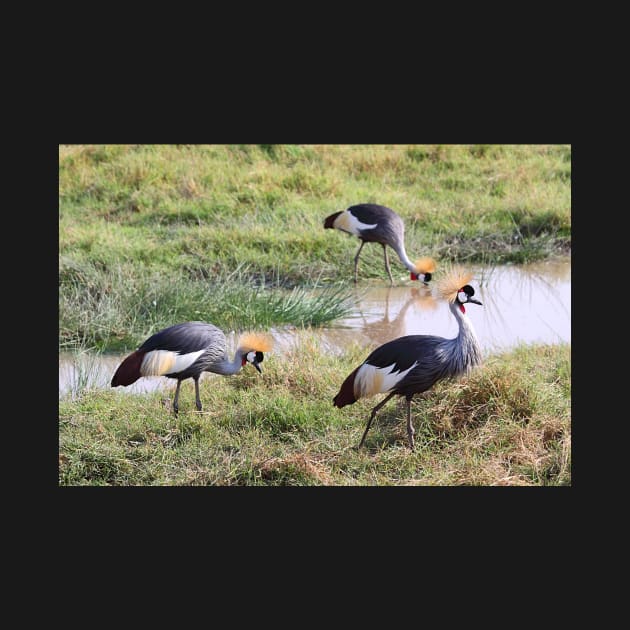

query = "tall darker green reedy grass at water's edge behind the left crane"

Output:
[[59, 261, 354, 350]]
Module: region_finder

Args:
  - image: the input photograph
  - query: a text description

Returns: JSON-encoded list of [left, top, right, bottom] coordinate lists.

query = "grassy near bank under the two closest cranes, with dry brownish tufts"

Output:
[[59, 344, 571, 486]]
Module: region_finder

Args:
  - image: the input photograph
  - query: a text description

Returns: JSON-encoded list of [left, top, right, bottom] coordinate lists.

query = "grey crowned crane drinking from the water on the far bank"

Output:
[[324, 203, 435, 285]]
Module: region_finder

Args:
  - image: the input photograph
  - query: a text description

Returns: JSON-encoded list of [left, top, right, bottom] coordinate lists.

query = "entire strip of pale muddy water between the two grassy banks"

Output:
[[59, 258, 571, 397]]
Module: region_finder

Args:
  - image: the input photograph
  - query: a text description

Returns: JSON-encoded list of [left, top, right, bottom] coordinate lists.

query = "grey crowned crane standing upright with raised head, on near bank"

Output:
[[333, 269, 481, 450]]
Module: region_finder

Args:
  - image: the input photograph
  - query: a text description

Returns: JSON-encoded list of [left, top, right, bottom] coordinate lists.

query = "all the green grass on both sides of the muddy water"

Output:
[[59, 145, 571, 486]]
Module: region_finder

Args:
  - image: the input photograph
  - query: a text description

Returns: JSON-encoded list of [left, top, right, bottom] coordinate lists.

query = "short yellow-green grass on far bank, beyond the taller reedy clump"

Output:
[[59, 145, 571, 274]]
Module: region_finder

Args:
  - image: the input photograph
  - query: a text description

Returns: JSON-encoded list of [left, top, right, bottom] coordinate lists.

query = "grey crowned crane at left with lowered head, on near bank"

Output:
[[112, 322, 272, 415]]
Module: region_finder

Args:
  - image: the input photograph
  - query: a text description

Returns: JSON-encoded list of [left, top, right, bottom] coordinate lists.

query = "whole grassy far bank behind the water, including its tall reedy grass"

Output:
[[59, 145, 571, 350]]
